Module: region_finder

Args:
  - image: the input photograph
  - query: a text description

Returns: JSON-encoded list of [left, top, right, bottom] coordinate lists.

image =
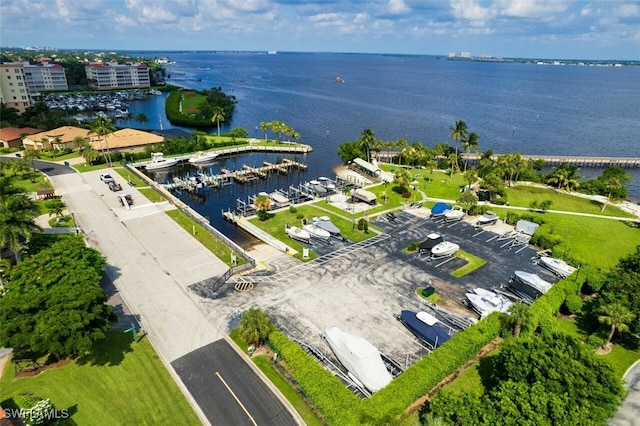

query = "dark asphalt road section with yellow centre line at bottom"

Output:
[[171, 340, 297, 426]]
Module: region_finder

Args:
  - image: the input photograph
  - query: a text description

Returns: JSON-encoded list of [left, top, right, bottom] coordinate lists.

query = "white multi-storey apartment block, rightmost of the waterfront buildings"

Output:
[[85, 62, 151, 90]]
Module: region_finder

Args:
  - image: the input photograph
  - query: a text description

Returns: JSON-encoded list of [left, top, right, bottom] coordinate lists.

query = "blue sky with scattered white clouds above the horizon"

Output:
[[0, 0, 640, 60]]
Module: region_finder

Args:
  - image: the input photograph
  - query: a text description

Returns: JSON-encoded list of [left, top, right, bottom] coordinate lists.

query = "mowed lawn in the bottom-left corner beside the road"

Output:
[[0, 330, 200, 425]]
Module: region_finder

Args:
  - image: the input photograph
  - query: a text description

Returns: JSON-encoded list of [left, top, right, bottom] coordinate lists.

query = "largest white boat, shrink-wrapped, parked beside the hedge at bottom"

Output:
[[324, 326, 393, 392]]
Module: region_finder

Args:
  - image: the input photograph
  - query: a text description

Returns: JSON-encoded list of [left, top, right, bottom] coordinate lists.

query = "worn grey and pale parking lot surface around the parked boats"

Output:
[[195, 209, 555, 372]]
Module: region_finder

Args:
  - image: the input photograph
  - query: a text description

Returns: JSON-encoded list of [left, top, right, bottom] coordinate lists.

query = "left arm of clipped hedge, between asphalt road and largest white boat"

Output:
[[269, 331, 360, 425]]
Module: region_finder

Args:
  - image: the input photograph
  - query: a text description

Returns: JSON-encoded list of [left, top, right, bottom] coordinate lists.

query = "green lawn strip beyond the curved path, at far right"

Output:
[[507, 185, 634, 217]]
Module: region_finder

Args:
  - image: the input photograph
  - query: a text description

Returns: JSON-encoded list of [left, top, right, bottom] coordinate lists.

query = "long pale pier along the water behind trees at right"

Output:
[[376, 151, 640, 169]]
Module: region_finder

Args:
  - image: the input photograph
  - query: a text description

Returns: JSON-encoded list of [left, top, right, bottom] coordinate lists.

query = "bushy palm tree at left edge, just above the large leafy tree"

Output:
[[0, 178, 40, 261]]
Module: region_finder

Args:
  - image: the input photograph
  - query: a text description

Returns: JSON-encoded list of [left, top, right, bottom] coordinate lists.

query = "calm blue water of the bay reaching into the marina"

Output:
[[122, 52, 640, 245]]
